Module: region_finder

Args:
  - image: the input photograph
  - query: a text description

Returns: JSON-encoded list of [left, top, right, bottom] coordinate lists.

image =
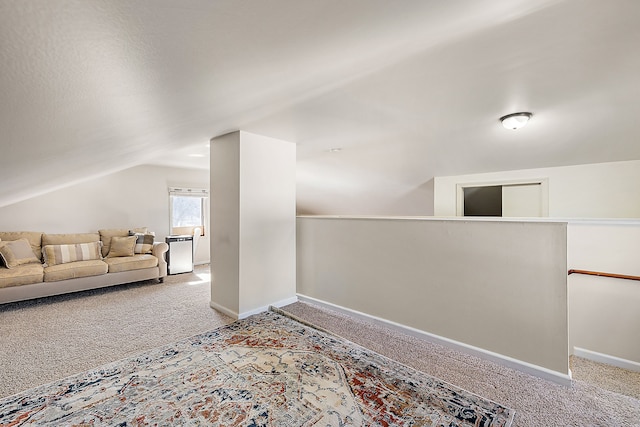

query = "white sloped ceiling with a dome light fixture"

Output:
[[0, 0, 640, 215]]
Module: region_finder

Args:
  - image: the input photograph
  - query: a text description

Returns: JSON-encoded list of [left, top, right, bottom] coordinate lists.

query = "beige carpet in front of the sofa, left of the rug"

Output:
[[0, 266, 233, 396]]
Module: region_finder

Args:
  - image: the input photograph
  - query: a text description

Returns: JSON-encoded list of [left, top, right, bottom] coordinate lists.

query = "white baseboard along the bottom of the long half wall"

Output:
[[298, 294, 571, 386]]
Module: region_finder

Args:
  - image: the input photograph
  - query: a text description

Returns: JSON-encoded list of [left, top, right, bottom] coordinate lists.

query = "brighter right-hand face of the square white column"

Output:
[[240, 132, 296, 313]]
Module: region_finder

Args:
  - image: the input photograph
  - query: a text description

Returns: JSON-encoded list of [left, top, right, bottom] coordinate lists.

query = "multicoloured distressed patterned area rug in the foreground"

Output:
[[0, 312, 514, 427]]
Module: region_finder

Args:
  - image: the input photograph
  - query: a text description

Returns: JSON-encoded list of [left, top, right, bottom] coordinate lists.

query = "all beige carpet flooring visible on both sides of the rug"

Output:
[[0, 266, 640, 427]]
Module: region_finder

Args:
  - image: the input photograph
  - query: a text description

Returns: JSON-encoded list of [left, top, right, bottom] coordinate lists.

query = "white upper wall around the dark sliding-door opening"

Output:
[[434, 160, 640, 218]]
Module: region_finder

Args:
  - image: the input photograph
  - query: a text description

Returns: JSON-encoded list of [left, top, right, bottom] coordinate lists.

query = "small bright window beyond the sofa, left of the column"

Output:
[[169, 187, 209, 236]]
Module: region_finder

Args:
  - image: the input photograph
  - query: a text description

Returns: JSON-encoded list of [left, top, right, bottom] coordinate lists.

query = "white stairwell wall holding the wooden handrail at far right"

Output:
[[567, 221, 640, 370]]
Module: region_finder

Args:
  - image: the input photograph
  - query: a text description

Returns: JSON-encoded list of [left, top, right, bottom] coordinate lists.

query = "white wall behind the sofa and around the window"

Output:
[[0, 165, 209, 262]]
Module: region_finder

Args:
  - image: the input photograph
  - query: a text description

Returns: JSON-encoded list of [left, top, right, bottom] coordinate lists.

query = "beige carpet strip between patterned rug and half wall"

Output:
[[282, 302, 640, 427]]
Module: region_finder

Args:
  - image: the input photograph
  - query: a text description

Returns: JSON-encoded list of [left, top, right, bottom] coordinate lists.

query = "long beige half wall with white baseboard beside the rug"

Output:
[[297, 217, 569, 382]]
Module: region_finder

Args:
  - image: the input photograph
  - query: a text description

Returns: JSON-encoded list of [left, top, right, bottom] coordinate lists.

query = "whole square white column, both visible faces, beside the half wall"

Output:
[[210, 132, 296, 318]]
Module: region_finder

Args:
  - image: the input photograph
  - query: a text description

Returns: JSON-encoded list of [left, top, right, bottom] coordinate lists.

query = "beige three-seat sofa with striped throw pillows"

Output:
[[0, 228, 169, 304]]
